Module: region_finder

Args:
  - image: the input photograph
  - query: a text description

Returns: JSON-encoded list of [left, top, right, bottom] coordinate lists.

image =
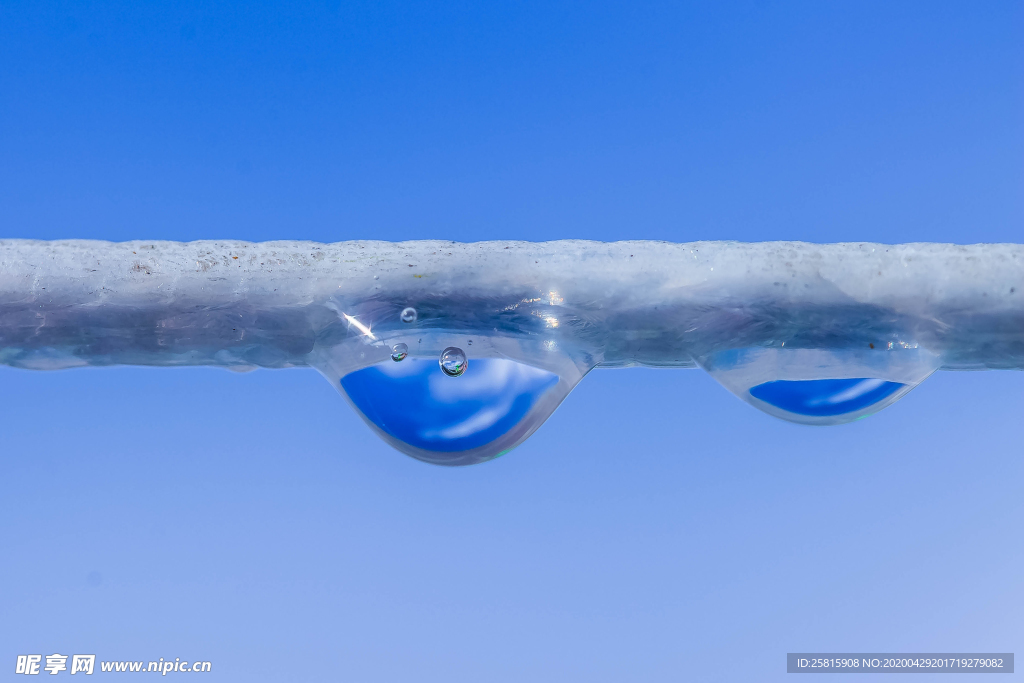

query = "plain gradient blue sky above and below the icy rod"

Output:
[[0, 1, 1024, 682]]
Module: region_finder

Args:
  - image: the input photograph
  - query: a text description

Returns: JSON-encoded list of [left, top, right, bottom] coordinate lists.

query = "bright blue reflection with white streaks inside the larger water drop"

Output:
[[341, 357, 558, 455]]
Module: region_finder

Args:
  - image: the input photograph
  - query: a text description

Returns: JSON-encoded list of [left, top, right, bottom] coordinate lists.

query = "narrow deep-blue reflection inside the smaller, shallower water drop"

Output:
[[751, 378, 906, 418]]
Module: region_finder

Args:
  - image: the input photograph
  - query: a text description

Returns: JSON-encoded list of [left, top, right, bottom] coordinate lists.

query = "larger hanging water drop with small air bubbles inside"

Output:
[[308, 307, 596, 465]]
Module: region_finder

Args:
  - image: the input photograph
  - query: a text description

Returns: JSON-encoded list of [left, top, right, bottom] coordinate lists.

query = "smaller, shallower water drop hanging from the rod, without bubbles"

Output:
[[700, 345, 939, 425]]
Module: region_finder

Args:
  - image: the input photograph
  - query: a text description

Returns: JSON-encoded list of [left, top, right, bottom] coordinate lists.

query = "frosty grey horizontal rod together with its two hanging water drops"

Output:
[[0, 240, 1024, 464]]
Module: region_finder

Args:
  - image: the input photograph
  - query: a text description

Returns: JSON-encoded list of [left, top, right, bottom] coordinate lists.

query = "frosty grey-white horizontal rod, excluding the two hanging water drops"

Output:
[[0, 240, 1024, 370]]
